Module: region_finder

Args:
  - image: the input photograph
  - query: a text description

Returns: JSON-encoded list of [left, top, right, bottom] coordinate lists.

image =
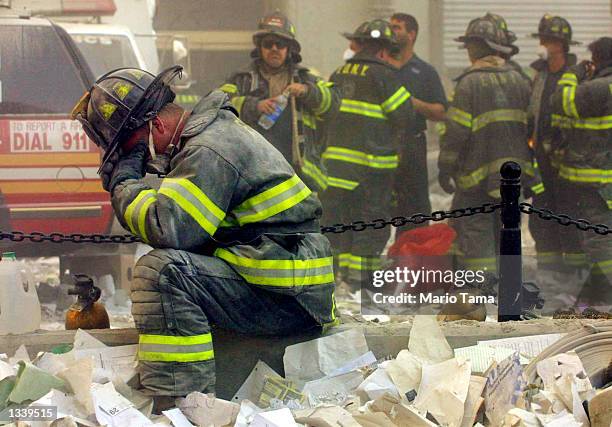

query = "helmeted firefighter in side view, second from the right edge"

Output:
[[529, 15, 586, 283]]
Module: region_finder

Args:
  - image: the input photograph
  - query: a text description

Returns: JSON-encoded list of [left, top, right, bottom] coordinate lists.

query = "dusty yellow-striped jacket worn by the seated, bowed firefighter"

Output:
[[112, 91, 336, 325]]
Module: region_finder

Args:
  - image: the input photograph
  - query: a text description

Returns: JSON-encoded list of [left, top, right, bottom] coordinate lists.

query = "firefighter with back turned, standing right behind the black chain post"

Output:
[[438, 17, 539, 273]]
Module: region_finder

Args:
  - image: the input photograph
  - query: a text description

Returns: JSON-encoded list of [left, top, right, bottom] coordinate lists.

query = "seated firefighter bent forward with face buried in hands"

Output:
[[73, 67, 336, 410]]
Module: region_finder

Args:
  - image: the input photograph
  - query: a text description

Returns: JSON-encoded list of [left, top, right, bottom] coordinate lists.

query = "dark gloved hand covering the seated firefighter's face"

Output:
[[100, 141, 148, 193]]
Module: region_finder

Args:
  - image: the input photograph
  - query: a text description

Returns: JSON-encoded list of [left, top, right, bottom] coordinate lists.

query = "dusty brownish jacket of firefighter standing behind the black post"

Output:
[[438, 56, 544, 198]]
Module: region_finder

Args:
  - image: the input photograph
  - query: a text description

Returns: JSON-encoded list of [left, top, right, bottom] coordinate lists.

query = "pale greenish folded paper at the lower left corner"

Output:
[[9, 361, 65, 403]]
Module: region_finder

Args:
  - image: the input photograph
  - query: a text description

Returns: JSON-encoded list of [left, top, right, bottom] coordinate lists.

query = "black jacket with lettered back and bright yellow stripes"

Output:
[[323, 53, 414, 191]]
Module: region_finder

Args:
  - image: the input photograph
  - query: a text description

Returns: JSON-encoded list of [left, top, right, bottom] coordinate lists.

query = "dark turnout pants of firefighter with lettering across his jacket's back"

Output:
[[322, 173, 393, 290]]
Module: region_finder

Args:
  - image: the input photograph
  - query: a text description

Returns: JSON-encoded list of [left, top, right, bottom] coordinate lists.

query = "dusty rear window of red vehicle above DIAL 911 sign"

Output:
[[0, 25, 87, 114]]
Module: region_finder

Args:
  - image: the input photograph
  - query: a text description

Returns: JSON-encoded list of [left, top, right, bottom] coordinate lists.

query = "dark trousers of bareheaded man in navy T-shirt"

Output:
[[394, 132, 431, 228]]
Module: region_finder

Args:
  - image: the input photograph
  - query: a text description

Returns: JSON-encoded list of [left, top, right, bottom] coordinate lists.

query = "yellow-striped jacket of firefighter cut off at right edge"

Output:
[[552, 66, 612, 204]]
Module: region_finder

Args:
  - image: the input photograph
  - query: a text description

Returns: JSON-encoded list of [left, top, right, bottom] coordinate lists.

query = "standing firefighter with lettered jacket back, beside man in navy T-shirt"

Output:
[[323, 20, 414, 290]]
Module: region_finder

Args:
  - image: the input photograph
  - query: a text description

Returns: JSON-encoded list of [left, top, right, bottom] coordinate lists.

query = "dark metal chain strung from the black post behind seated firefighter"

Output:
[[0, 203, 612, 244]]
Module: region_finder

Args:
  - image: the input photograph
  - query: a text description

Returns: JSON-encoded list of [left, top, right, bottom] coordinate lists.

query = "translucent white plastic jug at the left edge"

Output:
[[0, 252, 41, 335]]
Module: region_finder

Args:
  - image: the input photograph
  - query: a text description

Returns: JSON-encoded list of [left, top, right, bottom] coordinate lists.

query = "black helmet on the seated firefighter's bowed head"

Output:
[[72, 65, 183, 168]]
